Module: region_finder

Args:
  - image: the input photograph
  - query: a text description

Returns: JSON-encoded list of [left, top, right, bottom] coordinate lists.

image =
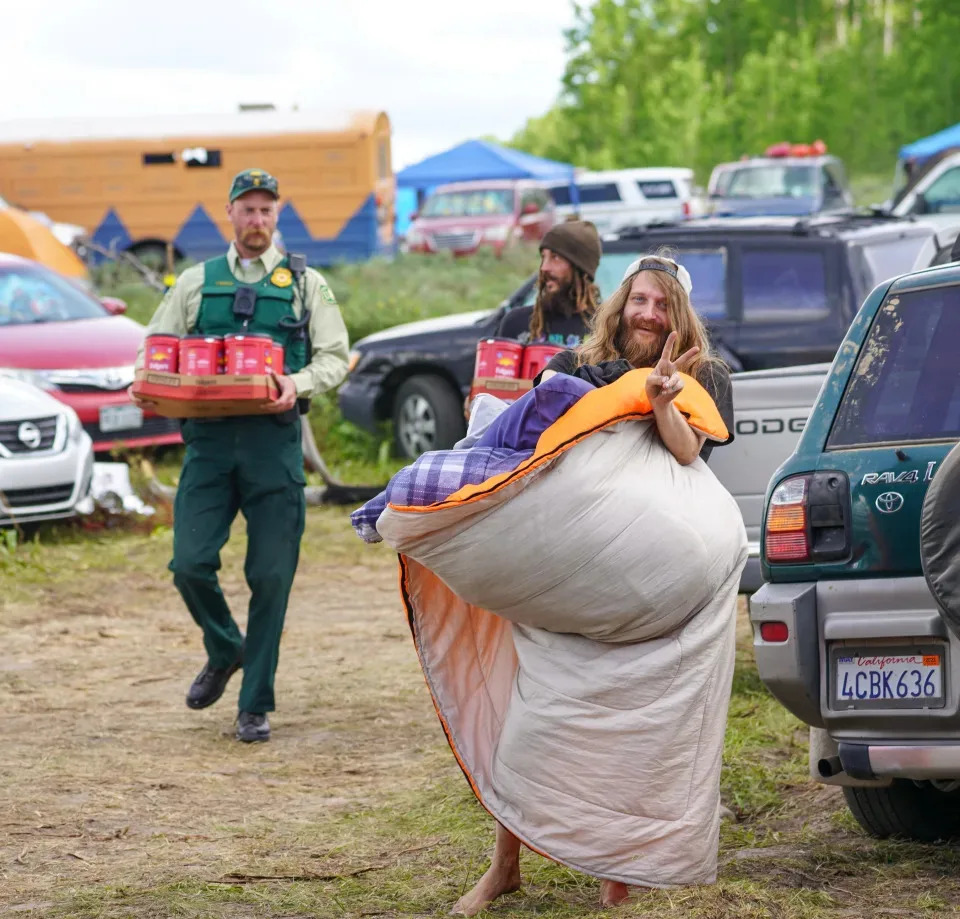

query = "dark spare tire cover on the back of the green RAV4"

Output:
[[920, 444, 960, 635]]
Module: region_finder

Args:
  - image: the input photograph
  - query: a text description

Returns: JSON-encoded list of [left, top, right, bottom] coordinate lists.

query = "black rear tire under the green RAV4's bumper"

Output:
[[843, 779, 960, 842]]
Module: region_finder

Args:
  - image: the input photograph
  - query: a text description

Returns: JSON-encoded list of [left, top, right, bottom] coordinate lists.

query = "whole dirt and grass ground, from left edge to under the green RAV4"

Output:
[[0, 511, 960, 919]]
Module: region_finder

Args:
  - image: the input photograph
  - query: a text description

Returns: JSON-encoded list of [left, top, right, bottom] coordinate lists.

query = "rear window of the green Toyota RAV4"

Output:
[[827, 286, 960, 449]]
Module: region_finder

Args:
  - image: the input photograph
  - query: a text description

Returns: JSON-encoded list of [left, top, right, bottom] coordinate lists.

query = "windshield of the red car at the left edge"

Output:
[[0, 265, 109, 327]]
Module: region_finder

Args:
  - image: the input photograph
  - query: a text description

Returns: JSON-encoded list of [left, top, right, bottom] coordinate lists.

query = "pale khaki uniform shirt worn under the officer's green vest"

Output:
[[137, 243, 349, 396]]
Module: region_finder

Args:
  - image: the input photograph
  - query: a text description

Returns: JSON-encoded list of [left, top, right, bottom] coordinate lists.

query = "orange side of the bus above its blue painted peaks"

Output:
[[0, 117, 394, 242]]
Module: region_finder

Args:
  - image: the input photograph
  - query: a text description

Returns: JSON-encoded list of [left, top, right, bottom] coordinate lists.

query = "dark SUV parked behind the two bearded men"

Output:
[[339, 215, 937, 458]]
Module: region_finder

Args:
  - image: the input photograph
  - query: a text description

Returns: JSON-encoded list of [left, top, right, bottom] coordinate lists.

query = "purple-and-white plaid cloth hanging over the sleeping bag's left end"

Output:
[[350, 447, 533, 542]]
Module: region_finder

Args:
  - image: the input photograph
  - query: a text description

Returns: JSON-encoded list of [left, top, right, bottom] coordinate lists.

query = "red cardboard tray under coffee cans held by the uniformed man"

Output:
[[132, 370, 279, 418]]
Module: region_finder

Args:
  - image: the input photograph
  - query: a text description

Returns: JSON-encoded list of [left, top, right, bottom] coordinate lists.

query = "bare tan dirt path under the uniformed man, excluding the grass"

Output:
[[0, 516, 442, 914]]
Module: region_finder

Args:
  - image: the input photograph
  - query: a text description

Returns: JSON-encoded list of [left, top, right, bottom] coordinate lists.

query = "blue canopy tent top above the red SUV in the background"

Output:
[[396, 140, 579, 219]]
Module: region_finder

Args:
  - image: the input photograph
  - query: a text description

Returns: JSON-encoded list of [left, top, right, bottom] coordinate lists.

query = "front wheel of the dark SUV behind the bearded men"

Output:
[[393, 376, 465, 459]]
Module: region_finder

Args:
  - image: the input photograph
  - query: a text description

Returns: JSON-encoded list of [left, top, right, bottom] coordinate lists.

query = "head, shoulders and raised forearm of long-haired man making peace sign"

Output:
[[534, 255, 734, 463]]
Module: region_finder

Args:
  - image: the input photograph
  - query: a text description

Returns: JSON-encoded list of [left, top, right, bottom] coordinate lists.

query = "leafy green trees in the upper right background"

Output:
[[510, 0, 960, 181]]
